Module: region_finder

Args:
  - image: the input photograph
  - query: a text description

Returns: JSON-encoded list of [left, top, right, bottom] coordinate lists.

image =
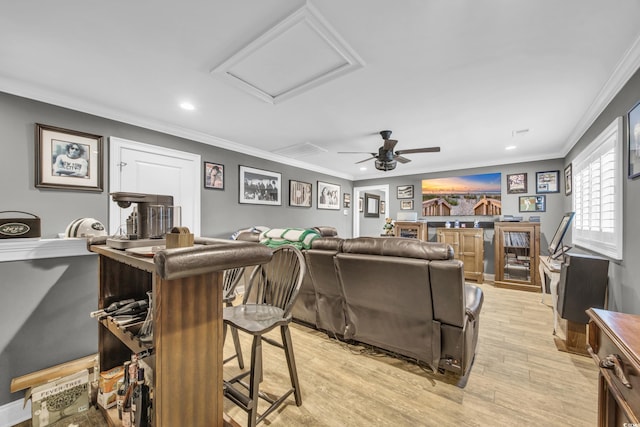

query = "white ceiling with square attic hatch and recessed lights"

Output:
[[0, 0, 640, 180]]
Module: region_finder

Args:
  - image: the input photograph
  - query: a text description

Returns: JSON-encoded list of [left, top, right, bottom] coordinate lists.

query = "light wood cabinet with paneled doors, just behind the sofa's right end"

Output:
[[436, 227, 484, 283]]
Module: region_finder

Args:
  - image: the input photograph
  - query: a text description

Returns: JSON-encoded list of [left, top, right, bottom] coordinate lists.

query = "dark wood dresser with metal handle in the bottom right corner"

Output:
[[587, 308, 640, 426]]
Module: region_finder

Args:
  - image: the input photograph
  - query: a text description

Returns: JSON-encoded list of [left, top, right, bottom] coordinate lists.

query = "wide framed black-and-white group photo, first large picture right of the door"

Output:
[[239, 165, 282, 206]]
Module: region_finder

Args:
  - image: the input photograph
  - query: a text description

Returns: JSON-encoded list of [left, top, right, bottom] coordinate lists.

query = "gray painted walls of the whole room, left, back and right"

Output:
[[0, 62, 640, 405]]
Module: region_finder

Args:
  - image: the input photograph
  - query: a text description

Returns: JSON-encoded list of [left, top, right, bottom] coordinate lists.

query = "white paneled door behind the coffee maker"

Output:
[[109, 137, 201, 236]]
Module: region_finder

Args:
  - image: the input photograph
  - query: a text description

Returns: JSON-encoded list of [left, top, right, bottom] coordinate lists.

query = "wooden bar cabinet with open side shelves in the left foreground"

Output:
[[91, 242, 270, 427]]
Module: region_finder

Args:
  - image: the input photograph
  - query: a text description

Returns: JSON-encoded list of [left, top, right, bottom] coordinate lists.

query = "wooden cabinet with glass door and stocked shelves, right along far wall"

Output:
[[494, 222, 542, 292]]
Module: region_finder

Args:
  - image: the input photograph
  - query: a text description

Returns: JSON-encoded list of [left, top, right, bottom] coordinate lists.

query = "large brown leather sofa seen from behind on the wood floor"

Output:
[[293, 237, 484, 386]]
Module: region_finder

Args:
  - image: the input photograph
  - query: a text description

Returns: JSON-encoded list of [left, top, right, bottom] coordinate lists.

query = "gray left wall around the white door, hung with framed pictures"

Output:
[[0, 93, 357, 405]]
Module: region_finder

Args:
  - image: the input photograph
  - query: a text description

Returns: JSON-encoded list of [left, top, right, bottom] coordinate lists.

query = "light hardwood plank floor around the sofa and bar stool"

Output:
[[224, 284, 598, 427]]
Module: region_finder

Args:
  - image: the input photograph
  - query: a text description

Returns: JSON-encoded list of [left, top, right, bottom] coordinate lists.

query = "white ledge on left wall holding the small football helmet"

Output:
[[0, 238, 95, 262]]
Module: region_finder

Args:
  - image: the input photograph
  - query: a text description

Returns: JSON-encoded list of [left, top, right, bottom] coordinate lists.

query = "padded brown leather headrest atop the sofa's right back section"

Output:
[[342, 237, 453, 260]]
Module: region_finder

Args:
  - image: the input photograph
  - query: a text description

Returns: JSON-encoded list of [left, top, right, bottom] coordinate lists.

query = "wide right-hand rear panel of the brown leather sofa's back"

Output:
[[335, 252, 440, 366]]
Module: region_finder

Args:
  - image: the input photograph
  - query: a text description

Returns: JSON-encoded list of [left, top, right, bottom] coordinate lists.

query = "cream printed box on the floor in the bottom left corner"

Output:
[[25, 369, 89, 427]]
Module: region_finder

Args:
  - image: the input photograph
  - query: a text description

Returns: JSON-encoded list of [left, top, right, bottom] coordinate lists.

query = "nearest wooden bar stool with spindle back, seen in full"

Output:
[[223, 245, 306, 427]]
